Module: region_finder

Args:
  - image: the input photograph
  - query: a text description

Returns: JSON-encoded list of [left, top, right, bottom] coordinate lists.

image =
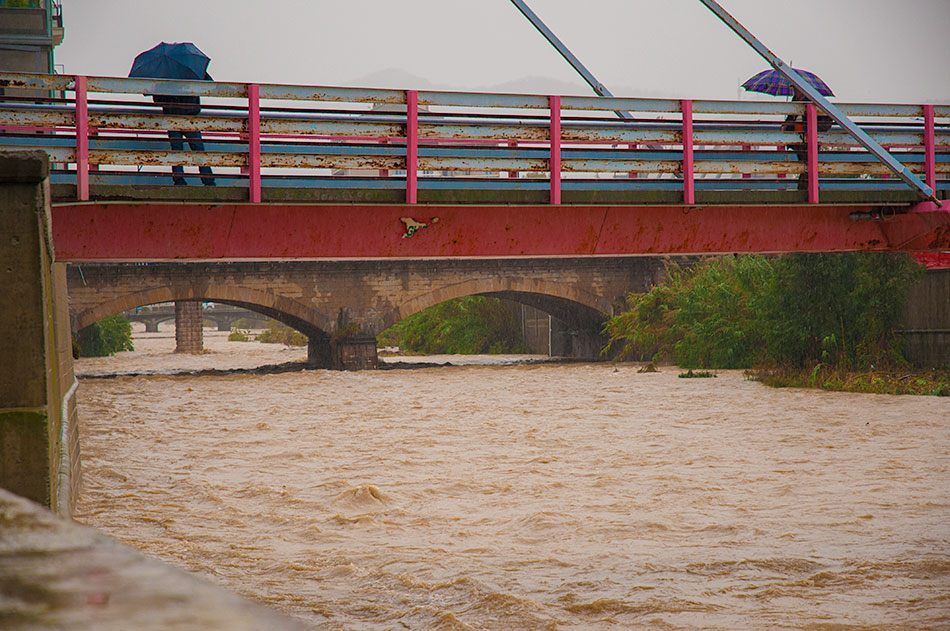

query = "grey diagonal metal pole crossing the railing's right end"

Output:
[[704, 0, 941, 206]]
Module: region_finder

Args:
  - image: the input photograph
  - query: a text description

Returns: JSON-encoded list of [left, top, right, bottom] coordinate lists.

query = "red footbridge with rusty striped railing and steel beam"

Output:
[[0, 73, 950, 262]]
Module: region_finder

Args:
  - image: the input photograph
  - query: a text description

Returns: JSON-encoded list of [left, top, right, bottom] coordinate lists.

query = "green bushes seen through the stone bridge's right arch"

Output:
[[377, 296, 525, 355]]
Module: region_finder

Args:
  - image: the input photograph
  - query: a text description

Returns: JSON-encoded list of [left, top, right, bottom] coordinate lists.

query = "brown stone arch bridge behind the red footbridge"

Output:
[[67, 257, 664, 368]]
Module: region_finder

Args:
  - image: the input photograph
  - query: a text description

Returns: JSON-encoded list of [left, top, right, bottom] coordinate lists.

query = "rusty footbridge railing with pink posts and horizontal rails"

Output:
[[0, 73, 950, 204]]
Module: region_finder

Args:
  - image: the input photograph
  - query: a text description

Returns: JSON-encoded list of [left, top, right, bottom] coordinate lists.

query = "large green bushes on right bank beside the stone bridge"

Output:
[[605, 253, 941, 392]]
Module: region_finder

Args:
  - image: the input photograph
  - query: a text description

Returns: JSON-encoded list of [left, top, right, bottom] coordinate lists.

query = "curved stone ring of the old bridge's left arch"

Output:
[[72, 285, 332, 337]]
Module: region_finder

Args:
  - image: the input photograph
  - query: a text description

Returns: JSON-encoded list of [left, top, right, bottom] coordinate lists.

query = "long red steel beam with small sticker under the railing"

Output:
[[52, 202, 950, 262]]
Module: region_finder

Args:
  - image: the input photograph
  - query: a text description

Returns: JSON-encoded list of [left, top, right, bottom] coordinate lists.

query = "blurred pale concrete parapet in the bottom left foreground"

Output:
[[0, 489, 312, 631]]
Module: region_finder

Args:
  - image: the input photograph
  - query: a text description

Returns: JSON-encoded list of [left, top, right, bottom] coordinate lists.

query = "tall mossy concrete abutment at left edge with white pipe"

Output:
[[0, 152, 80, 515]]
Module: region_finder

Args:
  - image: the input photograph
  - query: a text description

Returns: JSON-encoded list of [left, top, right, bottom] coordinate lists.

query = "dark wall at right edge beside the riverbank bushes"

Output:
[[902, 269, 950, 368]]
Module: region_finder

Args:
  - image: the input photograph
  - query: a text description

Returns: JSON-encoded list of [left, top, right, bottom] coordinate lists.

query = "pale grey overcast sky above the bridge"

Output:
[[56, 0, 950, 104]]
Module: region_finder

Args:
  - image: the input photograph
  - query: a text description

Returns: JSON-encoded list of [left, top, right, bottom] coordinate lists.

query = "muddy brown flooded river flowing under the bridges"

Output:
[[76, 332, 950, 631]]
